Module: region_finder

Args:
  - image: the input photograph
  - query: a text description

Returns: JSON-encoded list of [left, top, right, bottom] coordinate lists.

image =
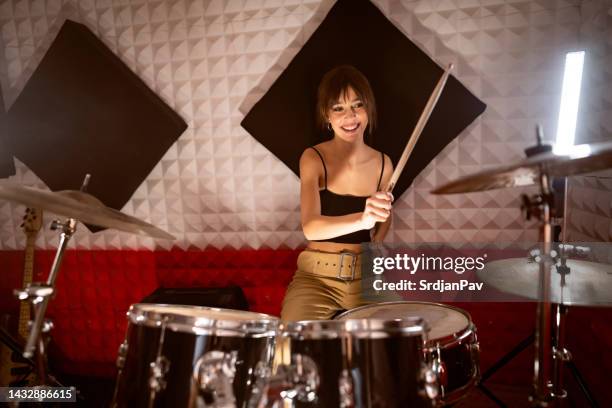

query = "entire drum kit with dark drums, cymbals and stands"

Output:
[[0, 133, 612, 408]]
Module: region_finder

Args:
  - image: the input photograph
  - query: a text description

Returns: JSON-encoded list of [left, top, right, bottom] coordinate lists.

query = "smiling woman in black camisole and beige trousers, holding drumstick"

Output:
[[281, 66, 393, 321]]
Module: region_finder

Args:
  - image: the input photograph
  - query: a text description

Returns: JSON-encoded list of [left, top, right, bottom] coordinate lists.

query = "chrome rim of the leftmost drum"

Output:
[[126, 303, 279, 337]]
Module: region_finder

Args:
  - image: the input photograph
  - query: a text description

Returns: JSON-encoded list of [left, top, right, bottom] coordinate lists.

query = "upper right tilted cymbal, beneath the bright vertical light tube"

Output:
[[432, 142, 612, 194]]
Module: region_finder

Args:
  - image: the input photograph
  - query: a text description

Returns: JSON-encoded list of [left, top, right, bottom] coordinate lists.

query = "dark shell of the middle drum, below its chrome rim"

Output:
[[291, 335, 432, 408]]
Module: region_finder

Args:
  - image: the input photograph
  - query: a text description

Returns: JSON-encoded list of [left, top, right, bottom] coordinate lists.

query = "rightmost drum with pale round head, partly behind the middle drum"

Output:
[[337, 302, 480, 404]]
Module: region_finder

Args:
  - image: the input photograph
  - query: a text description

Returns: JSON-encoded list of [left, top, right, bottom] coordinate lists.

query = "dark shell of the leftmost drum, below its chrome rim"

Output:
[[113, 306, 274, 407]]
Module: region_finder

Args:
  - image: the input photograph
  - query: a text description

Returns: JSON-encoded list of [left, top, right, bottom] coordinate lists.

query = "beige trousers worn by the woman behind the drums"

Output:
[[281, 250, 369, 322]]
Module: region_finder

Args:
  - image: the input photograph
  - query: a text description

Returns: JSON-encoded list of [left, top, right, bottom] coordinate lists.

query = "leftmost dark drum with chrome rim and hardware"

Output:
[[113, 304, 278, 408]]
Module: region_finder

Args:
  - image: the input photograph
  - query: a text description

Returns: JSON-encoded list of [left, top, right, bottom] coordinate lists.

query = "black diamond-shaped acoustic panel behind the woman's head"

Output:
[[241, 0, 486, 197]]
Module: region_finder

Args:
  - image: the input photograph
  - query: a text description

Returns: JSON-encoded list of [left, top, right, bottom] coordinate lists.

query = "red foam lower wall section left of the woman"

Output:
[[0, 249, 299, 376]]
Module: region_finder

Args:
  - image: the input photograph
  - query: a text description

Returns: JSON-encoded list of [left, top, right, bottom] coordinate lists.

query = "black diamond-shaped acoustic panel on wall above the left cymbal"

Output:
[[5, 20, 187, 215]]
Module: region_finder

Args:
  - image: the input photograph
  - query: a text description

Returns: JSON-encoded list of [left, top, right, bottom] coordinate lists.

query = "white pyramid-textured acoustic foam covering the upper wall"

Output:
[[0, 0, 610, 249]]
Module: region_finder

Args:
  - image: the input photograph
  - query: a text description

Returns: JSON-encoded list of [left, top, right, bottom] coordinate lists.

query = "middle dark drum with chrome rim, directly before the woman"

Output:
[[281, 319, 438, 408]]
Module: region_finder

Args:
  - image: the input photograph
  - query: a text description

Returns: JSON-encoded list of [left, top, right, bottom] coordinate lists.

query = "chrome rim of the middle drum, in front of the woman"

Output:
[[280, 317, 427, 340]]
